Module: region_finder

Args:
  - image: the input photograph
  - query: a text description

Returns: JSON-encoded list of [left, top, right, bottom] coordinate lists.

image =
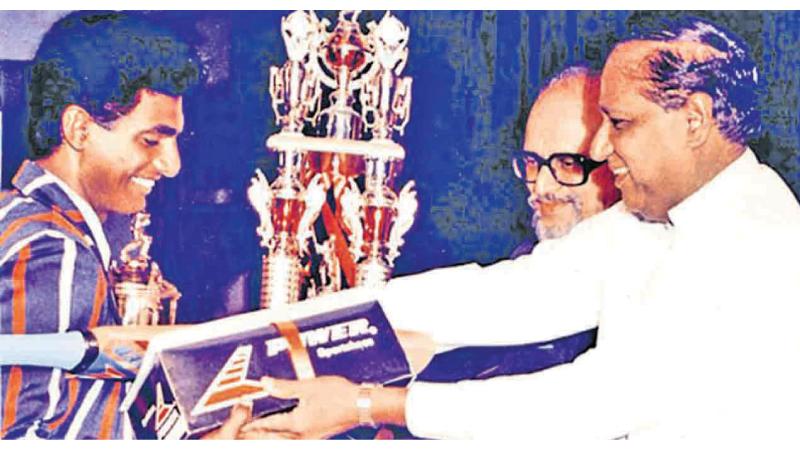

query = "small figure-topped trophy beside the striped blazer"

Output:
[[111, 211, 181, 325]]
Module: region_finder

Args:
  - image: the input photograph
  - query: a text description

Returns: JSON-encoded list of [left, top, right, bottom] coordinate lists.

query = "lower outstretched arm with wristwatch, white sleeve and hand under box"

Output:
[[231, 344, 644, 439]]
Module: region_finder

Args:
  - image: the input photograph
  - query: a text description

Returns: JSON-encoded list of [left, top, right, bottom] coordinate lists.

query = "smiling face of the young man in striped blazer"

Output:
[[77, 90, 183, 219]]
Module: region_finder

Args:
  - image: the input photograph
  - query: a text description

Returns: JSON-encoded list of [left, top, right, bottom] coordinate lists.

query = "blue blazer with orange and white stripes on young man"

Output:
[[0, 161, 130, 439]]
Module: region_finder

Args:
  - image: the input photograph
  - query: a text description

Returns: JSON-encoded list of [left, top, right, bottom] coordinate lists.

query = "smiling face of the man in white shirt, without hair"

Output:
[[591, 41, 695, 222]]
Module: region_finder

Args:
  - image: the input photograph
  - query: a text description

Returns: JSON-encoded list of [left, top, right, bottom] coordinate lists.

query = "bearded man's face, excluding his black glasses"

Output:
[[523, 75, 614, 239]]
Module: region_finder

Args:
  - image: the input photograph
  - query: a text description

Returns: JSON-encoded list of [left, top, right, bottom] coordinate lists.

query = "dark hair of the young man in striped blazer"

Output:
[[26, 13, 199, 158]]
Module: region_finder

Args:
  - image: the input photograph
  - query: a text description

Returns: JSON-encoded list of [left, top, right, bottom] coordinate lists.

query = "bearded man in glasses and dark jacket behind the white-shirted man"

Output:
[[406, 66, 619, 402]]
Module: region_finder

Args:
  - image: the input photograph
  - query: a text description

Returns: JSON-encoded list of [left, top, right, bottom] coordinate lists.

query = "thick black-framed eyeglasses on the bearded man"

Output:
[[513, 150, 606, 186]]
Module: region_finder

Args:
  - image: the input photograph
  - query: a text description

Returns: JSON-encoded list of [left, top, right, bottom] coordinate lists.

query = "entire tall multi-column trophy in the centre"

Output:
[[248, 11, 417, 308]]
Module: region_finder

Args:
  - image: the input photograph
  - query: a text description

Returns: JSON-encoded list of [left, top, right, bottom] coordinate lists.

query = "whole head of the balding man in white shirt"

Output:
[[592, 20, 758, 222]]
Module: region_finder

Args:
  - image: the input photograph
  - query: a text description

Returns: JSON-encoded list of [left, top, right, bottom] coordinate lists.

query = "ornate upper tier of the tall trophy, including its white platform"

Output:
[[267, 11, 412, 160]]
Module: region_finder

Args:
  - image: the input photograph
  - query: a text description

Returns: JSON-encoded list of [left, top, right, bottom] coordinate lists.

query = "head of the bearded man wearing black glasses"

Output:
[[512, 67, 619, 253]]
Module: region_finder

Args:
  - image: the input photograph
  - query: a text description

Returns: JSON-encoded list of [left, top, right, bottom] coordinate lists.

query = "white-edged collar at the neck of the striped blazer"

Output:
[[12, 160, 111, 269]]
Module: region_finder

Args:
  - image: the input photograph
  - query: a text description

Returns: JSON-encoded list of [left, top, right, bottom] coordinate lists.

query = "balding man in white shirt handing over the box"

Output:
[[244, 16, 800, 439]]
